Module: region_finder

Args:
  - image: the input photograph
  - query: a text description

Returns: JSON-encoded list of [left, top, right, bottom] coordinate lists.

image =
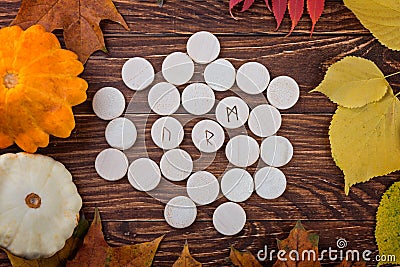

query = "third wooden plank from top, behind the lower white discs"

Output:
[[4, 115, 398, 221]]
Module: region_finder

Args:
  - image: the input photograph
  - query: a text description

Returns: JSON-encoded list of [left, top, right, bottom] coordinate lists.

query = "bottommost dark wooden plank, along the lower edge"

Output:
[[0, 220, 377, 267]]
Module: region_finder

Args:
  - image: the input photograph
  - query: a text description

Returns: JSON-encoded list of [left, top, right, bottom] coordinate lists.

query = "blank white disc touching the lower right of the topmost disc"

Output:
[[204, 58, 236, 91]]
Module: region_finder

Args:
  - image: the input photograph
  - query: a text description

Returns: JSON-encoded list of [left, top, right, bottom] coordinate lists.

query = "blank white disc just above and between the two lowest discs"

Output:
[[186, 171, 219, 205]]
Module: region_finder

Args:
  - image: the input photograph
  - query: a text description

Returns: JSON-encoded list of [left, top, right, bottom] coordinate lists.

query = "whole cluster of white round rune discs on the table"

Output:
[[93, 31, 300, 235]]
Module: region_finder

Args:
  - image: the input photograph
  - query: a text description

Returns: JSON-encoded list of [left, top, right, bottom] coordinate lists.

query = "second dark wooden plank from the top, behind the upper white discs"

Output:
[[75, 36, 400, 114]]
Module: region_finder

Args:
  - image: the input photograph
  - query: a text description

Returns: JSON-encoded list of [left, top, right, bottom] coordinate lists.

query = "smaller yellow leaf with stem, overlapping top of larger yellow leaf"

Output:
[[313, 57, 389, 108]]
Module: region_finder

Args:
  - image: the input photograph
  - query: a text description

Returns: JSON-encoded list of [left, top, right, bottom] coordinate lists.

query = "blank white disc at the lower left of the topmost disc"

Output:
[[162, 52, 194, 85]]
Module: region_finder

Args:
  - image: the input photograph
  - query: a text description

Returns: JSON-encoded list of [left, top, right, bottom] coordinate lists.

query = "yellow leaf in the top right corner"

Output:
[[344, 0, 400, 50]]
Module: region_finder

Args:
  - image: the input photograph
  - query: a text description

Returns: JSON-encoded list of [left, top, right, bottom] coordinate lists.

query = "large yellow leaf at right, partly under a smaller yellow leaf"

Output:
[[329, 87, 400, 195]]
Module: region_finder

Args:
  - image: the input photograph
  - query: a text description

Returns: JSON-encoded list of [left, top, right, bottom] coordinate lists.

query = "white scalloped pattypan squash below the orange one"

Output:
[[0, 153, 82, 259]]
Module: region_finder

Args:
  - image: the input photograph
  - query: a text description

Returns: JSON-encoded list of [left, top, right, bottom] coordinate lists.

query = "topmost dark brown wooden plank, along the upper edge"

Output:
[[0, 0, 369, 35]]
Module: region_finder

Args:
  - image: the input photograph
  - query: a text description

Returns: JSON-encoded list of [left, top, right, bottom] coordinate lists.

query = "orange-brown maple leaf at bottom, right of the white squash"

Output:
[[67, 209, 164, 267]]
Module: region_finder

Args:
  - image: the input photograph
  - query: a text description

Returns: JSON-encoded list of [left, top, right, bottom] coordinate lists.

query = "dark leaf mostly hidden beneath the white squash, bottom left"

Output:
[[4, 216, 89, 267]]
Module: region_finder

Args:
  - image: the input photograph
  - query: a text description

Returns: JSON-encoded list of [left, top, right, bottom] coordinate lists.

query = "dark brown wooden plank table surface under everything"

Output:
[[0, 0, 400, 266]]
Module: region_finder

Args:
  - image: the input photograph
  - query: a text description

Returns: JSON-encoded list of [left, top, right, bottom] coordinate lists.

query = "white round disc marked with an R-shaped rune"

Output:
[[192, 120, 225, 153]]
